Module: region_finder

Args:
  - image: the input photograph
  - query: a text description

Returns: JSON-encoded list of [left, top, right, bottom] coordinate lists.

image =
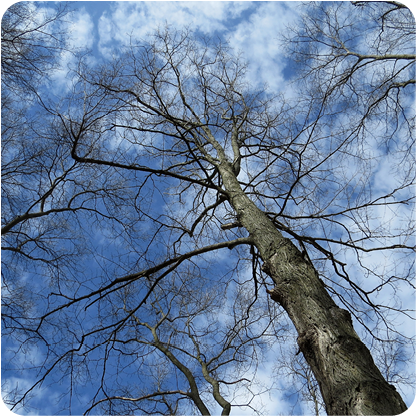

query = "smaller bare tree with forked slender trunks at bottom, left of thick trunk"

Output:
[[81, 270, 277, 415]]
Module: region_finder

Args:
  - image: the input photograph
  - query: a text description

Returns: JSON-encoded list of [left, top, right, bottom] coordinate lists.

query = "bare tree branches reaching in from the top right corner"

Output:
[[284, 1, 416, 154]]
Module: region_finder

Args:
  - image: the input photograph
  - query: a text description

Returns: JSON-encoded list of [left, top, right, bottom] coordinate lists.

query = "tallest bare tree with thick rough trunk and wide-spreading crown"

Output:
[[2, 2, 415, 415]]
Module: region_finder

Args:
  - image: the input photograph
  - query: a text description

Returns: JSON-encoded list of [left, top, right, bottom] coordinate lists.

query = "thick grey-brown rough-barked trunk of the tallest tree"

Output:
[[219, 162, 407, 415]]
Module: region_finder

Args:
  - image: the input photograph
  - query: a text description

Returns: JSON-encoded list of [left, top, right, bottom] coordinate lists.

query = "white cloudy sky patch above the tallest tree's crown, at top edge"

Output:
[[98, 2, 298, 90]]
